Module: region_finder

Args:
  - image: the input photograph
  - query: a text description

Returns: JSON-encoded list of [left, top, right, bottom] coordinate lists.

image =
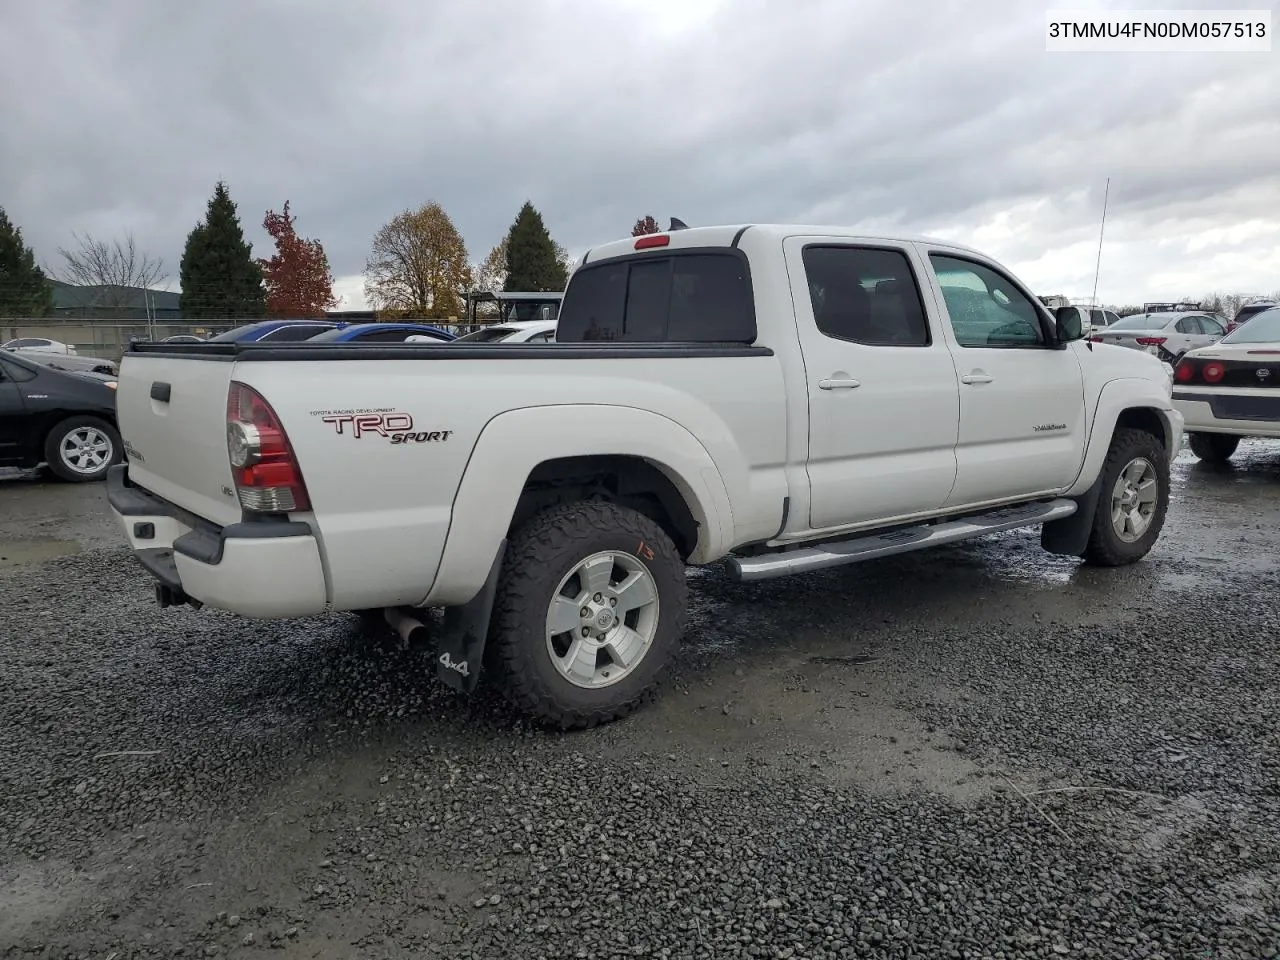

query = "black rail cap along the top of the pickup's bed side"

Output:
[[124, 343, 773, 364]]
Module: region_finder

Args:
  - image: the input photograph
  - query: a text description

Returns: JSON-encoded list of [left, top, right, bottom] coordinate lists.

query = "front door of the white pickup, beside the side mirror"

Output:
[[922, 244, 1087, 508]]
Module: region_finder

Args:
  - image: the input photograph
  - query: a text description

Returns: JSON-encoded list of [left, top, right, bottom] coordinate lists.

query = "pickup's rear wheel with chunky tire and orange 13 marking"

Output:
[[489, 502, 689, 730]]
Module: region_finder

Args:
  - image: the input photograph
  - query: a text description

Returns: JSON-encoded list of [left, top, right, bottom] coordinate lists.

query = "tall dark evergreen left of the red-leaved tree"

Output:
[[179, 180, 266, 320]]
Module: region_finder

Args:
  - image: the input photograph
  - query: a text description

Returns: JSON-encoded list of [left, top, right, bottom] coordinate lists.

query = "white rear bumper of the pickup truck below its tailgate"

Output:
[[106, 463, 328, 620]]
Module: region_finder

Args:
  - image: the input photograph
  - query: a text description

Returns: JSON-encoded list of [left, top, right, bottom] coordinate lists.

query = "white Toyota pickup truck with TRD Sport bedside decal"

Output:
[[109, 225, 1183, 727]]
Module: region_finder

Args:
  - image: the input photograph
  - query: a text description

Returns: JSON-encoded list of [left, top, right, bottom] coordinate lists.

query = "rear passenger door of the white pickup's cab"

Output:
[[785, 237, 959, 530]]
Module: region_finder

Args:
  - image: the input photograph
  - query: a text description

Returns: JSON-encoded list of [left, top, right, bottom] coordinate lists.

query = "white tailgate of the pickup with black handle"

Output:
[[115, 353, 241, 525]]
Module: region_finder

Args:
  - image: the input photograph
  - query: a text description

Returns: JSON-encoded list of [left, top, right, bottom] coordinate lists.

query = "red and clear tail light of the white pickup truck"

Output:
[[227, 380, 311, 513]]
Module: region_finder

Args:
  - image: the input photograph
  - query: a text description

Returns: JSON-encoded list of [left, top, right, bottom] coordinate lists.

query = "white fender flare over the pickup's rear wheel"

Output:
[[422, 403, 733, 607]]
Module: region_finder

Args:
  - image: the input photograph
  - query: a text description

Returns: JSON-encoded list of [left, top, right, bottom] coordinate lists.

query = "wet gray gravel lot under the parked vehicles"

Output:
[[0, 442, 1280, 960]]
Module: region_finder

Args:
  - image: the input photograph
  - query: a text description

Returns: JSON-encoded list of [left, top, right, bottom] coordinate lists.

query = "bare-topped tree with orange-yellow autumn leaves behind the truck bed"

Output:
[[365, 202, 472, 320]]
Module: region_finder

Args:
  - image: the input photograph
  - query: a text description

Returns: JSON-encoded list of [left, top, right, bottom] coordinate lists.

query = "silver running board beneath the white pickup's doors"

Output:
[[728, 499, 1076, 582]]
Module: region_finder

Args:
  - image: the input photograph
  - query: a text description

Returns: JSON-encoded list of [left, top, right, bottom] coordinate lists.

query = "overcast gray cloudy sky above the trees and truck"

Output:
[[0, 0, 1280, 307]]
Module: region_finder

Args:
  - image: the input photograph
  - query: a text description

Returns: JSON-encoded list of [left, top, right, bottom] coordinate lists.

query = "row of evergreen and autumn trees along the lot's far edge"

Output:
[[0, 180, 624, 320]]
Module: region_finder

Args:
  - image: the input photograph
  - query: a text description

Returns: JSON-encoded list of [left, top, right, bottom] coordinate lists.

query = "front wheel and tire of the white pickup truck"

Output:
[[1084, 429, 1169, 567]]
